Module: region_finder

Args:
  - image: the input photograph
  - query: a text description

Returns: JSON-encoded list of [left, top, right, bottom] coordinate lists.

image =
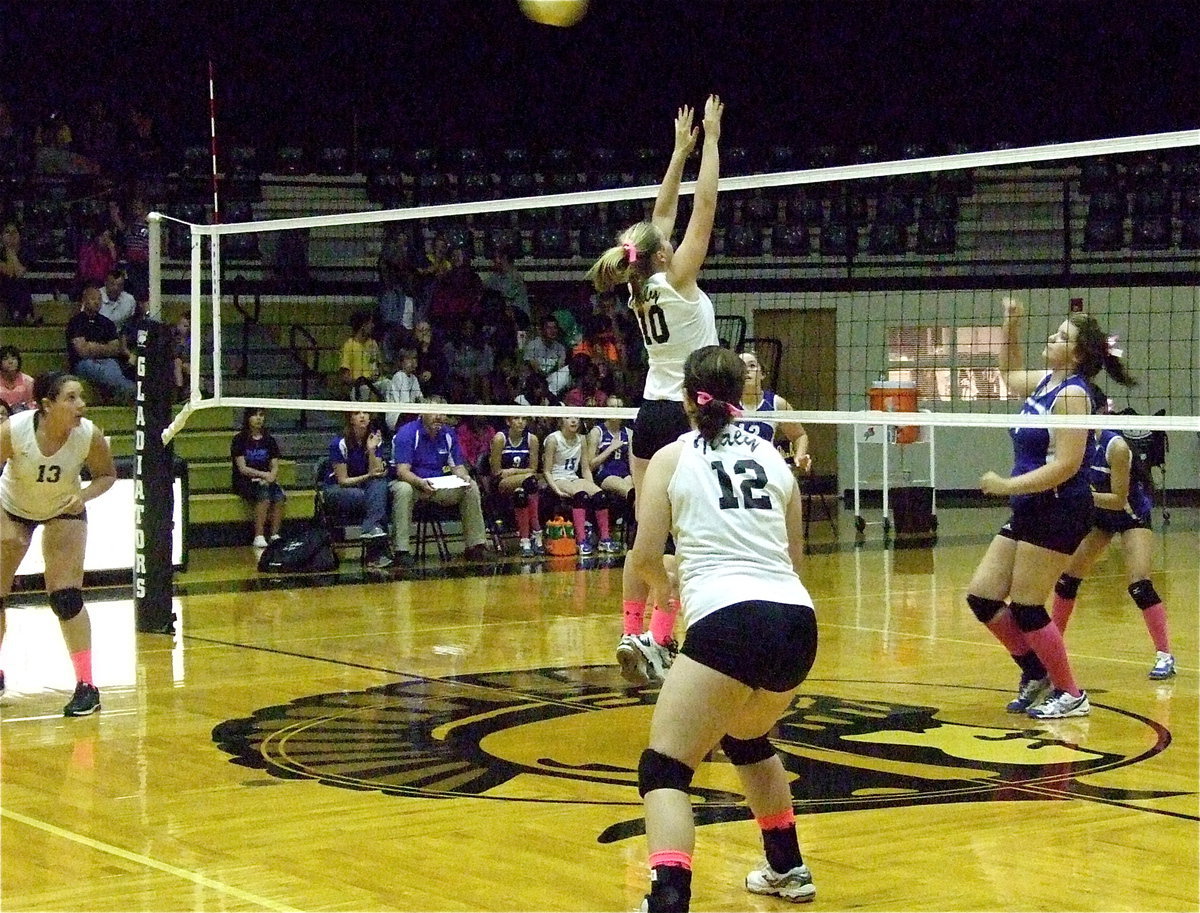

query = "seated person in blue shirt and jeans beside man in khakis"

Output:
[[319, 412, 388, 539]]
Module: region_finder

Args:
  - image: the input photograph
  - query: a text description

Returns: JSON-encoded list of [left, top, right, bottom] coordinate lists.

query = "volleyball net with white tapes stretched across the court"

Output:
[[151, 125, 1200, 487]]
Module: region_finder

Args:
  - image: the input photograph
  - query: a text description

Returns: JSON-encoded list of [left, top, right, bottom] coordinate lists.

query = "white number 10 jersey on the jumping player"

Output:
[[634, 272, 720, 402]]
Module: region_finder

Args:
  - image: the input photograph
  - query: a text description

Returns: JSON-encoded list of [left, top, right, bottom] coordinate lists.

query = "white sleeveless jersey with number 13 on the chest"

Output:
[[0, 409, 96, 521]]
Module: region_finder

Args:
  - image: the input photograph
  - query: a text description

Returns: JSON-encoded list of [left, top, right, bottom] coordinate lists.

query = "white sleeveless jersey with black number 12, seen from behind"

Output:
[[667, 425, 812, 627]]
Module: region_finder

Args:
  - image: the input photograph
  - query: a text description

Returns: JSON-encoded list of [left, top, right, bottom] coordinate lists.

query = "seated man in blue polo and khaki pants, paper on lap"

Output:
[[391, 396, 488, 564]]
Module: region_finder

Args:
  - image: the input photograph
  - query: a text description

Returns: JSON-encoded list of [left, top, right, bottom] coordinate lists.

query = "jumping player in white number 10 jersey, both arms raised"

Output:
[[588, 95, 725, 684]]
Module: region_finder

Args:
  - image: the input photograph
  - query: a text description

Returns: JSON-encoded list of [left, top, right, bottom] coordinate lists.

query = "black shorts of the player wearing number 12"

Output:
[[679, 600, 817, 691]]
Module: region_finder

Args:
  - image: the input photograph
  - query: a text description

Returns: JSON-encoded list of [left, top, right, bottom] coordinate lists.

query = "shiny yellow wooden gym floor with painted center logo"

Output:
[[0, 509, 1200, 911]]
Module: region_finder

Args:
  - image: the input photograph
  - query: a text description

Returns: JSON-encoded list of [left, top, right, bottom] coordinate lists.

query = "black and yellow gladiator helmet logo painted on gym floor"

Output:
[[212, 666, 1186, 842]]
